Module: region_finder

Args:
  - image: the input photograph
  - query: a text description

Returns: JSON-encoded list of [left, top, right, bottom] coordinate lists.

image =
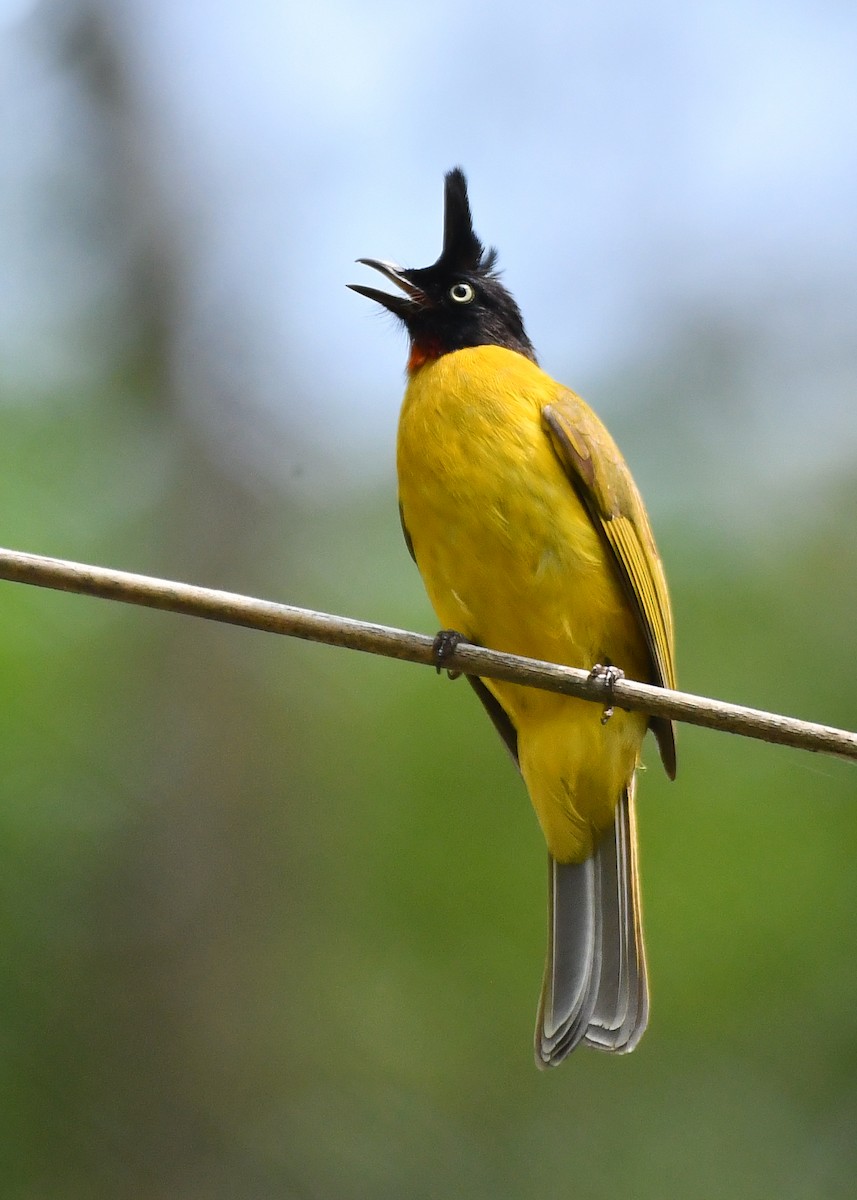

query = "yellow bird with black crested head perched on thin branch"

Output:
[[348, 167, 676, 1068]]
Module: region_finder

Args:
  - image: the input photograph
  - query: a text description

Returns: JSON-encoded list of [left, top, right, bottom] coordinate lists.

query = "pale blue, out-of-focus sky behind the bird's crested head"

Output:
[[0, 0, 857, 496]]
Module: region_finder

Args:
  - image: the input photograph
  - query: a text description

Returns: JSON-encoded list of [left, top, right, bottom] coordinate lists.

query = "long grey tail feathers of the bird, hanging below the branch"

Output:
[[535, 779, 648, 1067]]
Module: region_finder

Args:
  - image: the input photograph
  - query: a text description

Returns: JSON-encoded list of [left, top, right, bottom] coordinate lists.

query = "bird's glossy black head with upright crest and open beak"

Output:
[[348, 167, 535, 370]]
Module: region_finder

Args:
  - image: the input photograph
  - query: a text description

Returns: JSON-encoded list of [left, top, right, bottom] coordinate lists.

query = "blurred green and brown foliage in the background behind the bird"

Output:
[[0, 2, 857, 1200]]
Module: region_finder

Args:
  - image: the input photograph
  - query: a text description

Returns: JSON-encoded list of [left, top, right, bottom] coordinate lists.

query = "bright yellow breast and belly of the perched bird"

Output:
[[398, 347, 649, 862]]
